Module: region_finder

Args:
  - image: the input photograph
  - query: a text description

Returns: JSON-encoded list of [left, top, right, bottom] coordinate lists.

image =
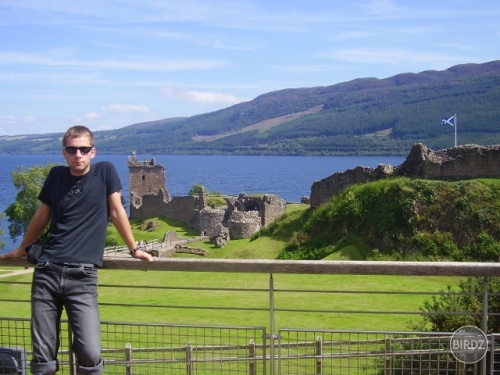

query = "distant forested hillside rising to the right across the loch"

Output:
[[0, 61, 500, 155]]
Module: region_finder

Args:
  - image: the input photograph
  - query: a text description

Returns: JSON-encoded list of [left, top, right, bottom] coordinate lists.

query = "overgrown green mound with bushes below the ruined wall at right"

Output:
[[268, 179, 500, 261]]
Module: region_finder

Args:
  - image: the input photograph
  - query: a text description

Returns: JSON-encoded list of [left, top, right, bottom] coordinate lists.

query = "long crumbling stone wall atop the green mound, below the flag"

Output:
[[310, 143, 500, 207]]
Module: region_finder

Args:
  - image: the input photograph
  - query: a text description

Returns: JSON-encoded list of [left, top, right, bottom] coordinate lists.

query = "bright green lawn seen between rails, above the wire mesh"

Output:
[[0, 267, 459, 330]]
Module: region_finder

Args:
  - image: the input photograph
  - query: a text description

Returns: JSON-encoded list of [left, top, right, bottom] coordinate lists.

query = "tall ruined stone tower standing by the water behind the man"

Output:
[[128, 151, 170, 212]]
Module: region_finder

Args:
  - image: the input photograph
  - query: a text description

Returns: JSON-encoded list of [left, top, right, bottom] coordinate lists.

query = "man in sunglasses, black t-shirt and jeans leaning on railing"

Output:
[[4, 126, 153, 375]]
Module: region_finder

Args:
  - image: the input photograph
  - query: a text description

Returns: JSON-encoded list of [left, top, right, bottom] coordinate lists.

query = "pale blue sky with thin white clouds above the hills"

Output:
[[0, 0, 500, 136]]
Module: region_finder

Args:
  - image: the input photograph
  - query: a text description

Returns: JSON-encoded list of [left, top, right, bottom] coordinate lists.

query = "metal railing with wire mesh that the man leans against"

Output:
[[0, 258, 500, 375]]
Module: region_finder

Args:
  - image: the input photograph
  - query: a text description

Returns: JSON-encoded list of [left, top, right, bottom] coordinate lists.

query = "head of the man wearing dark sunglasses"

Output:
[[63, 125, 96, 176]]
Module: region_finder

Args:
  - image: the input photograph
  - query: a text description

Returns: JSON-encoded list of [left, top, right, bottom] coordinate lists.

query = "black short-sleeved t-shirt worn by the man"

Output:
[[38, 161, 122, 266]]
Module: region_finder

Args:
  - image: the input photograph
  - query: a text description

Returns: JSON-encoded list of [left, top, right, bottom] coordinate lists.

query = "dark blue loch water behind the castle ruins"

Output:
[[0, 154, 405, 252]]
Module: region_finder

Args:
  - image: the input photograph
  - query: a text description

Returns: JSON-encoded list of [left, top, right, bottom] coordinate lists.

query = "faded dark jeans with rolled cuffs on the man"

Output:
[[31, 262, 104, 375]]
